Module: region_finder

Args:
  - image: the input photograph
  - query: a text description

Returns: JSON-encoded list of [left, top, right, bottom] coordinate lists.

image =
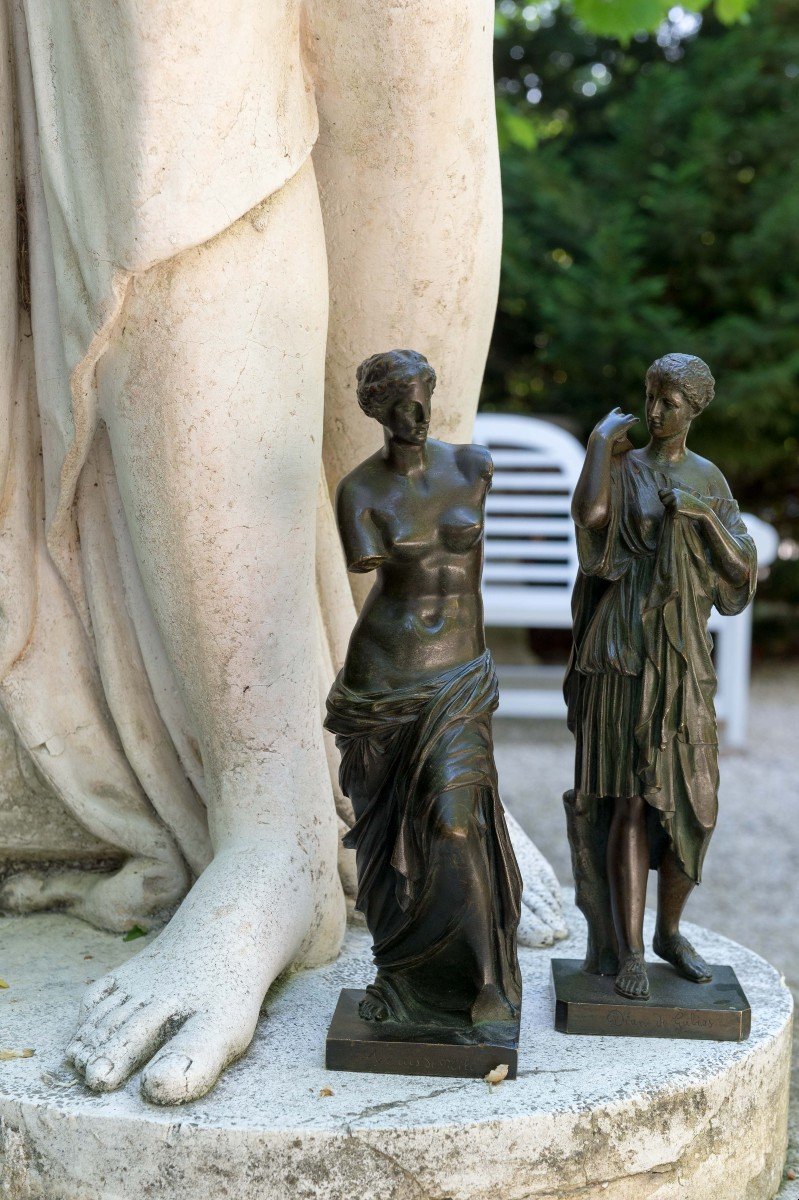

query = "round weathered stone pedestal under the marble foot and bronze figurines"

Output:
[[0, 911, 792, 1200]]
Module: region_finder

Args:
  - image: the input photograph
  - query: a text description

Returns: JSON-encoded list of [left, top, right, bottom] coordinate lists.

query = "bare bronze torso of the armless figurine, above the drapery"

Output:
[[337, 436, 492, 691]]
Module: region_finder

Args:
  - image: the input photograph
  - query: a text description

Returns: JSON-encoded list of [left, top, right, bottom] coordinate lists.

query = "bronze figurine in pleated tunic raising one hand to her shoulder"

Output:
[[551, 354, 757, 1037]]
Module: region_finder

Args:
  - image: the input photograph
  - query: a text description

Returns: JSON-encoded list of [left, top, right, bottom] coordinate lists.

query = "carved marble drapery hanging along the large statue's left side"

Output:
[[0, 0, 318, 928]]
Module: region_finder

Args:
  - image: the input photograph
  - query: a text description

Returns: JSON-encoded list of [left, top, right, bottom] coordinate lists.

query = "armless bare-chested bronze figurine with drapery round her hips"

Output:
[[325, 350, 522, 1075]]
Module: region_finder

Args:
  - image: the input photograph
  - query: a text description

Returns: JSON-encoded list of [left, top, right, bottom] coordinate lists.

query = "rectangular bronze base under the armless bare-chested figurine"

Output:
[[325, 988, 518, 1079]]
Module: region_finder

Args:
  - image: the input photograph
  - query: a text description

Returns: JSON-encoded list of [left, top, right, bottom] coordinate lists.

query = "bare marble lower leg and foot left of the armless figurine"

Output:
[[63, 163, 344, 1104]]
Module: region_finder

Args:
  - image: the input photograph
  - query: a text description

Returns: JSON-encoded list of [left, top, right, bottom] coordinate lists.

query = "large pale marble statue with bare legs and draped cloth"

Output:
[[0, 0, 560, 1103]]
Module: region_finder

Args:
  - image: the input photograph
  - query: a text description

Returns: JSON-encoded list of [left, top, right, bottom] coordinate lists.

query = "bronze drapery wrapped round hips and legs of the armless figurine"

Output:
[[325, 652, 522, 1024]]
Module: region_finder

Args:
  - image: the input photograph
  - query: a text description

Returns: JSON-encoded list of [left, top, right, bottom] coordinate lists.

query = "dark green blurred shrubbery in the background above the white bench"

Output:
[[485, 0, 799, 532]]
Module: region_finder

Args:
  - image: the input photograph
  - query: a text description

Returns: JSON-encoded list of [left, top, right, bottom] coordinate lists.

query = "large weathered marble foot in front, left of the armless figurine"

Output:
[[66, 848, 341, 1104]]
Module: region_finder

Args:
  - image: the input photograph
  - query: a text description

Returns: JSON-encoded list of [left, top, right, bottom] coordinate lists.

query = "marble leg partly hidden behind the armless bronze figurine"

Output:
[[310, 0, 566, 946]]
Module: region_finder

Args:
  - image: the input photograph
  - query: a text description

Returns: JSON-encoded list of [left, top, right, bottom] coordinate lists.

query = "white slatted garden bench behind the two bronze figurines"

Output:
[[474, 413, 777, 748]]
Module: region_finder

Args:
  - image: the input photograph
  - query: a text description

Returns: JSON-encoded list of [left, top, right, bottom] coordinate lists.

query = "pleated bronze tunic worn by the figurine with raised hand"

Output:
[[564, 452, 757, 883]]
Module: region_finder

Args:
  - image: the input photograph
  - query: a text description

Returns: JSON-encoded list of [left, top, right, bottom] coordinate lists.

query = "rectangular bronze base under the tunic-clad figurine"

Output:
[[552, 959, 752, 1042]]
